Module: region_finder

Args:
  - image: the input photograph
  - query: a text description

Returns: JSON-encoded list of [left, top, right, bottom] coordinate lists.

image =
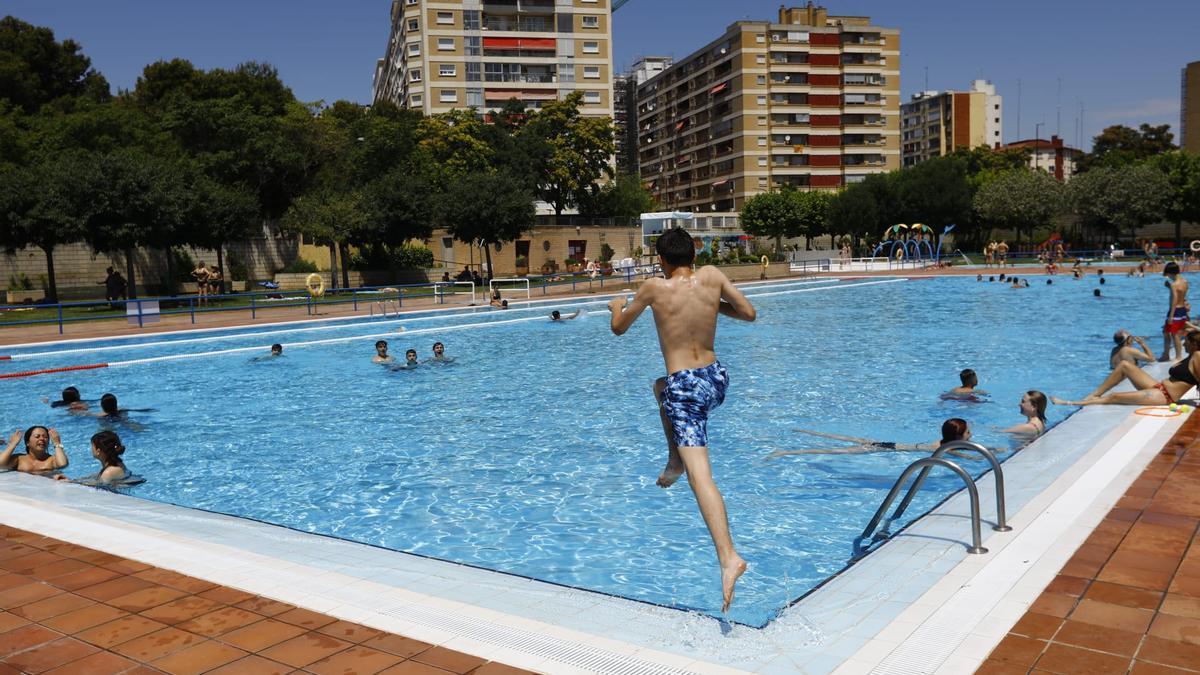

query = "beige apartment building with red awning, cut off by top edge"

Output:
[[373, 0, 613, 117]]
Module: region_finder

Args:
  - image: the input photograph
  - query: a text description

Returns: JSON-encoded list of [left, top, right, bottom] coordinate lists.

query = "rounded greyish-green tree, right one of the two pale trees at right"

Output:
[[1067, 165, 1171, 238]]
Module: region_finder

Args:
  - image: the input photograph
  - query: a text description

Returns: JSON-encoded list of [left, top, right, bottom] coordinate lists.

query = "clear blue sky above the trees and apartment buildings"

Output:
[[0, 0, 1200, 148]]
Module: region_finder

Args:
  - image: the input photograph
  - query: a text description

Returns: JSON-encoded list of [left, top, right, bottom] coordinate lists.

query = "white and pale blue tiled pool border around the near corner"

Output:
[[0, 366, 1182, 674]]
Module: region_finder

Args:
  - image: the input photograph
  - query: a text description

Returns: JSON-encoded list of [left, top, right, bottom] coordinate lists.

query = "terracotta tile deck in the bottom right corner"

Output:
[[979, 414, 1200, 675]]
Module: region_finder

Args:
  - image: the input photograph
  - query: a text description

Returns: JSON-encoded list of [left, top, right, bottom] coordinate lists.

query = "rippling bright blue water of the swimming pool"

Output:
[[0, 270, 1166, 626]]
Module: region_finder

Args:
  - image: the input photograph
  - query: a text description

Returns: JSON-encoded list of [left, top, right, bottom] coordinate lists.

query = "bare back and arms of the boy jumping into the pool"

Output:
[[613, 265, 755, 372]]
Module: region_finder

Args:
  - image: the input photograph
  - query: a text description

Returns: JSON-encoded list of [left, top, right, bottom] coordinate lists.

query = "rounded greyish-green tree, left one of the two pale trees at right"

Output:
[[973, 168, 1063, 239]]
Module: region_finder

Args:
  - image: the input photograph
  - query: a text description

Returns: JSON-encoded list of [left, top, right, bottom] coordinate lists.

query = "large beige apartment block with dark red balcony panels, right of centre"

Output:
[[637, 4, 900, 211]]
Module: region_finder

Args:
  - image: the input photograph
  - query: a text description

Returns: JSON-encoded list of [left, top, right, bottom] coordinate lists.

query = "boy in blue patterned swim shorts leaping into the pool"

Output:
[[608, 229, 757, 611]]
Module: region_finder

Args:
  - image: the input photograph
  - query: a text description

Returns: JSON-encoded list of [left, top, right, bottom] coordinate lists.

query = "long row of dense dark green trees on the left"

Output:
[[0, 17, 650, 301]]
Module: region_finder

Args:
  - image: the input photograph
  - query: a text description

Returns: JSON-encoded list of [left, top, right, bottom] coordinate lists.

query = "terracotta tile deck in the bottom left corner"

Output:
[[0, 525, 540, 675]]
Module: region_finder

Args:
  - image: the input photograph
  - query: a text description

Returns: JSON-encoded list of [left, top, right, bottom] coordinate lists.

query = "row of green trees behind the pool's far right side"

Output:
[[742, 125, 1200, 247]]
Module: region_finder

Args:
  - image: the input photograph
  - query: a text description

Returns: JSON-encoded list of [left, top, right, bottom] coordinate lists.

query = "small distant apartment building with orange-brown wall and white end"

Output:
[[900, 79, 1003, 168]]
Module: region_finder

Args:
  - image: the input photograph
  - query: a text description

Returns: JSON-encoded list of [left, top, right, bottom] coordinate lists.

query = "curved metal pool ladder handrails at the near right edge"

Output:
[[854, 441, 1012, 554]]
